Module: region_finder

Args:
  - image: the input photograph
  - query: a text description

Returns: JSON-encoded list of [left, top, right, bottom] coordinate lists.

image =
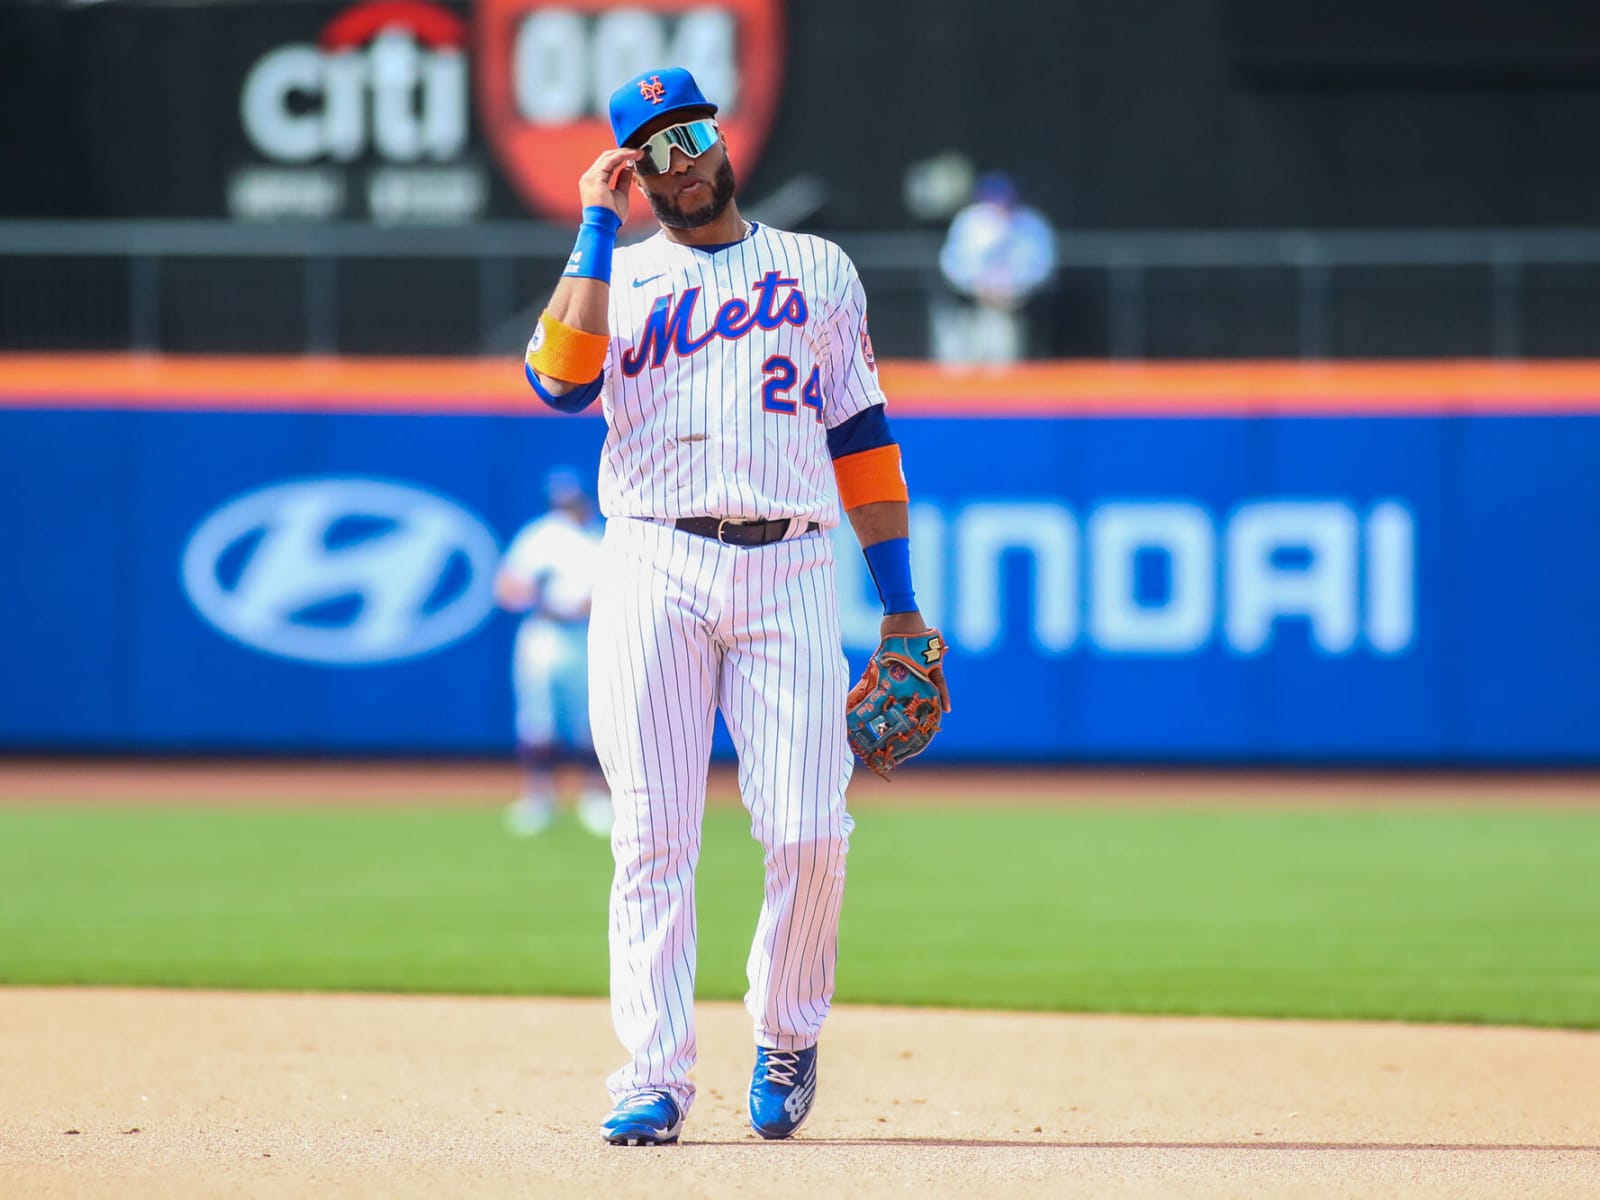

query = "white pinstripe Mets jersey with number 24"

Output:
[[600, 224, 883, 526]]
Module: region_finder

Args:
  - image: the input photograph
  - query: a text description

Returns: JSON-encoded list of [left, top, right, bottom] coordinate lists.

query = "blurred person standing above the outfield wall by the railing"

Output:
[[933, 171, 1056, 363]]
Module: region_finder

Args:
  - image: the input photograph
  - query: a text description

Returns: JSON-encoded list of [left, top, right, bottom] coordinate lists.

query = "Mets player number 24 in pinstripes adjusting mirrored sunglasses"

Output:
[[526, 67, 949, 1146]]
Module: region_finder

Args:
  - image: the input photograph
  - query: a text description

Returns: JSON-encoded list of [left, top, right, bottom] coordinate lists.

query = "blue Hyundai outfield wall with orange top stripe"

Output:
[[0, 357, 1600, 765]]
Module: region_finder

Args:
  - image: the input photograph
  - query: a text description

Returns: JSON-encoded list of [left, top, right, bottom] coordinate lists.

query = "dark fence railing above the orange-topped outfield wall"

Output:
[[0, 221, 1600, 358]]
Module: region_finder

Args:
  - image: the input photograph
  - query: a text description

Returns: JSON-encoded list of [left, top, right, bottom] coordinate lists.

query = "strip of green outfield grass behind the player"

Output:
[[0, 803, 1600, 1027]]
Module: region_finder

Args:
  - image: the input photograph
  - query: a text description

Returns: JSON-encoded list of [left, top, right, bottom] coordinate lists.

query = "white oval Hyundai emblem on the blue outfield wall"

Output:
[[182, 478, 498, 666]]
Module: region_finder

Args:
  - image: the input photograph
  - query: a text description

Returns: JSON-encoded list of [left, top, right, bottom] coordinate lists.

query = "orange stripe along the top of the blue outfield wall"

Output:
[[0, 354, 1600, 418]]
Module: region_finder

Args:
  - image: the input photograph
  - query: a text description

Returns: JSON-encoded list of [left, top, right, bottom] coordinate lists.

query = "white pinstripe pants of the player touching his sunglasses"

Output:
[[589, 518, 853, 1112]]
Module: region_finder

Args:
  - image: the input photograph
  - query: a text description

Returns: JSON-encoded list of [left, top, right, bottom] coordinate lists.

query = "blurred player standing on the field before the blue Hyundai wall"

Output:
[[494, 469, 611, 837]]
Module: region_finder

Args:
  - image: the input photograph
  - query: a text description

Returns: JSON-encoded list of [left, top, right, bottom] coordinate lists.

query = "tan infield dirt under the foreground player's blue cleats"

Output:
[[0, 989, 1600, 1198]]
